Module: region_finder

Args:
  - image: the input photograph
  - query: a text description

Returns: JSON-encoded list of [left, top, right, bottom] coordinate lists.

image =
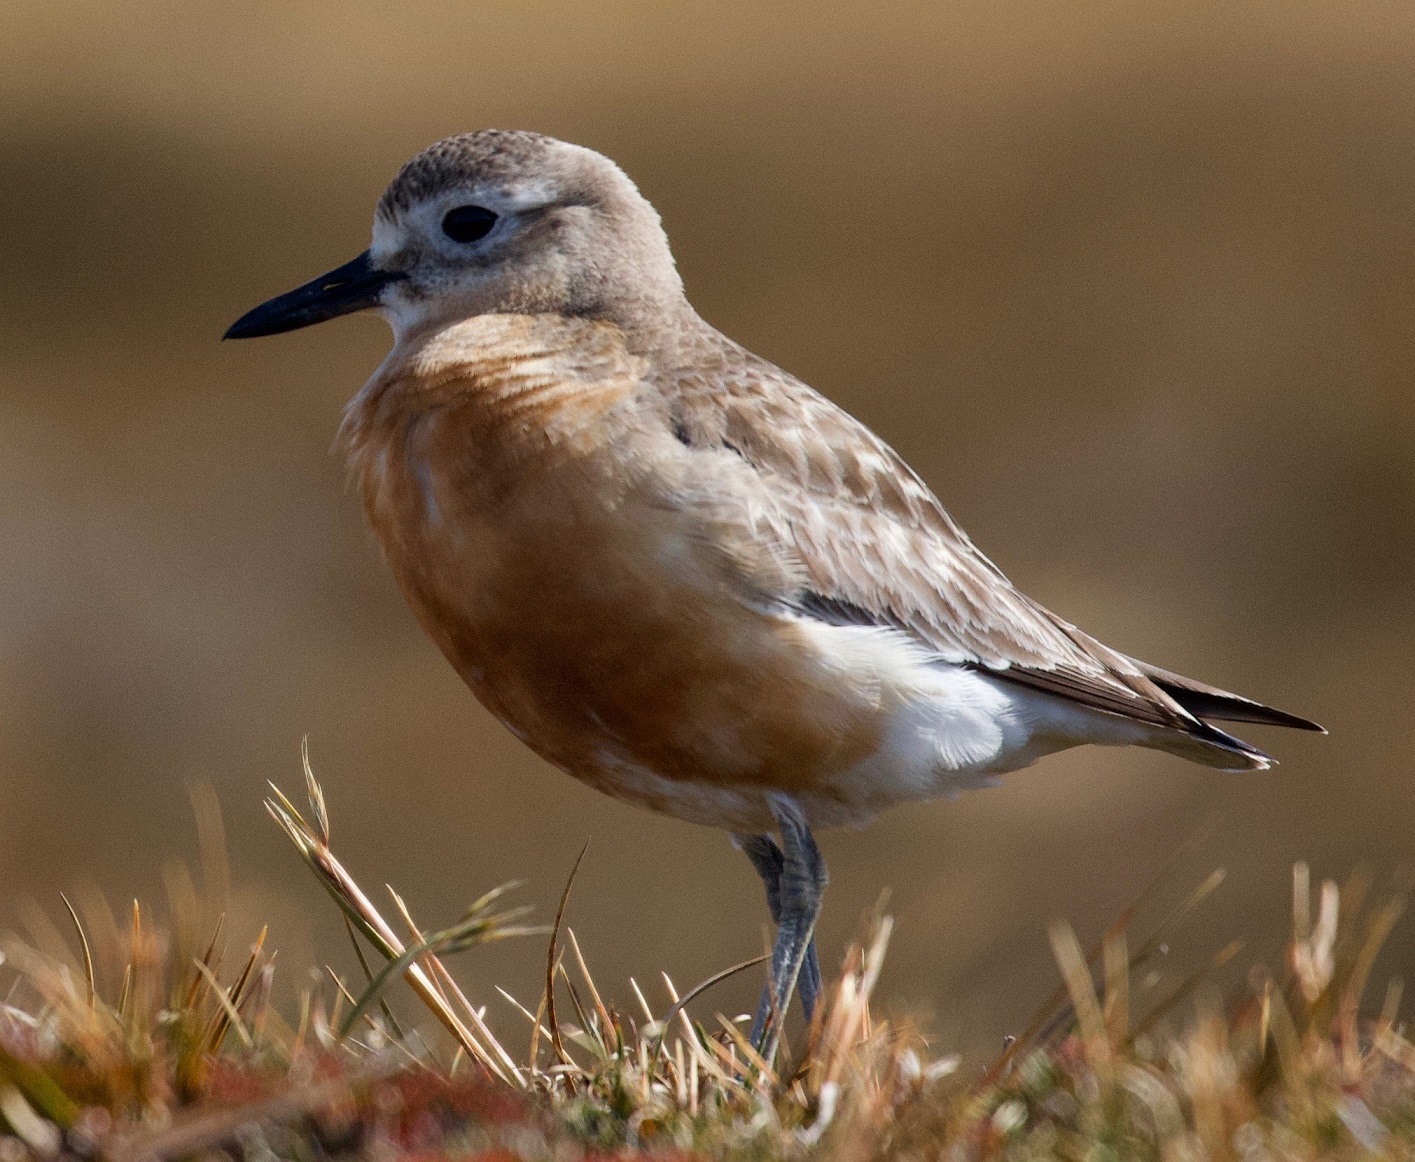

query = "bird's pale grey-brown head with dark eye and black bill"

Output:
[[226, 129, 683, 340]]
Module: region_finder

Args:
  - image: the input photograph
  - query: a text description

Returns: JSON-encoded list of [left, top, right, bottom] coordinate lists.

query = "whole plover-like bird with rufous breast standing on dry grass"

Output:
[[225, 129, 1322, 1060]]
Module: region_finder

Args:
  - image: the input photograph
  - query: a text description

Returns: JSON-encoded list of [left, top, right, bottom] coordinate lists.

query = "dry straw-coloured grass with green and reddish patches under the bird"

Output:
[[0, 764, 1415, 1162]]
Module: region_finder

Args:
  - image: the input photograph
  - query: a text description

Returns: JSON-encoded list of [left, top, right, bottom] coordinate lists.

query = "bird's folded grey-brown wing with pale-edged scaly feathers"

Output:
[[659, 340, 1204, 733]]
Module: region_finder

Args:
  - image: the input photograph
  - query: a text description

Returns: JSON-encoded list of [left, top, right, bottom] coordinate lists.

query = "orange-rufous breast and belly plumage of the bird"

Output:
[[342, 316, 882, 811]]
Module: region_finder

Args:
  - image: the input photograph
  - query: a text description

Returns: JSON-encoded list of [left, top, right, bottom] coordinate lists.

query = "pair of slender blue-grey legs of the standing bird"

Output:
[[737, 794, 828, 1062]]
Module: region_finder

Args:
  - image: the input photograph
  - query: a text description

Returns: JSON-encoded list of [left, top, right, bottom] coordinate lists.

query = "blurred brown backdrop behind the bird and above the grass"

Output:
[[0, 0, 1415, 1054]]
